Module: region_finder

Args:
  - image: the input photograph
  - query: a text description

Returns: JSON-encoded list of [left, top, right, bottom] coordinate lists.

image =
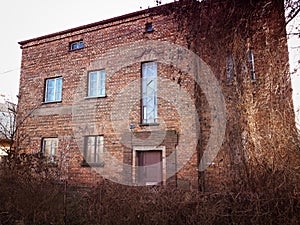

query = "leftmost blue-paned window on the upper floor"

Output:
[[45, 77, 62, 102]]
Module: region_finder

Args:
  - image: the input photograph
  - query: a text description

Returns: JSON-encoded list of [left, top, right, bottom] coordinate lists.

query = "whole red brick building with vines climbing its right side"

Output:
[[19, 0, 294, 189]]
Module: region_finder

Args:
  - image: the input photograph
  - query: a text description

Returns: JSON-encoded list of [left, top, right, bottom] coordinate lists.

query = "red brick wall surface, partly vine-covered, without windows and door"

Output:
[[18, 1, 293, 190]]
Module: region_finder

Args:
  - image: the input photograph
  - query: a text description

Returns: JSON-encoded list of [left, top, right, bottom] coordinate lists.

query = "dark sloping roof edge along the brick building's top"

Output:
[[18, 2, 176, 46]]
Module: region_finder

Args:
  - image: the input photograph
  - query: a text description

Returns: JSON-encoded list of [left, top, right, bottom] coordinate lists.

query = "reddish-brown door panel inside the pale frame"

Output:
[[137, 151, 162, 185]]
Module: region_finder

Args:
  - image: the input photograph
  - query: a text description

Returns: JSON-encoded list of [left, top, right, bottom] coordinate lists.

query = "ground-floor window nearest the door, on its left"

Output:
[[84, 136, 104, 165]]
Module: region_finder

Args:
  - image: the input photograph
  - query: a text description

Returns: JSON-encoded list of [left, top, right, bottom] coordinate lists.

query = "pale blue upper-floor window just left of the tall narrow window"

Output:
[[88, 70, 105, 97]]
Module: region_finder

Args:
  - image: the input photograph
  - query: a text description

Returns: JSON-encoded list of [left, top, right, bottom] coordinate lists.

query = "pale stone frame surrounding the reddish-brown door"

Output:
[[132, 146, 167, 185]]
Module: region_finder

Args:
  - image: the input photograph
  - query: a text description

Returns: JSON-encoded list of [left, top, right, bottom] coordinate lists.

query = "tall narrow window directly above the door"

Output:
[[142, 62, 157, 124]]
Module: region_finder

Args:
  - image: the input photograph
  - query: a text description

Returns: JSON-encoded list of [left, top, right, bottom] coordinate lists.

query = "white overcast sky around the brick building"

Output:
[[0, 0, 300, 121]]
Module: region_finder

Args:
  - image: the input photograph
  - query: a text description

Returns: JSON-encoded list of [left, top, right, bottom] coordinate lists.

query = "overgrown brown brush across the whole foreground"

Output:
[[0, 154, 300, 225]]
